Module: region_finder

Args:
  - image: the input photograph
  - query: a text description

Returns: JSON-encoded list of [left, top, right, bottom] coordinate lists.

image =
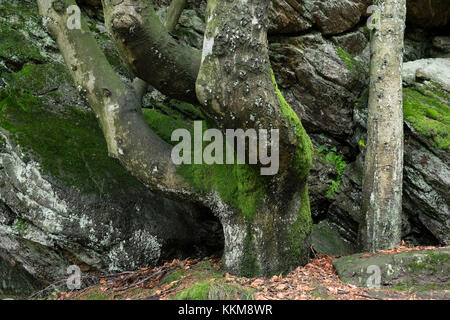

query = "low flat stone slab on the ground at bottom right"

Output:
[[333, 248, 450, 290]]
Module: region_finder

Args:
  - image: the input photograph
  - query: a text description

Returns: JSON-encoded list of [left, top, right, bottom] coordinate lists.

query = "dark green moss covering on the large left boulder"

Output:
[[0, 64, 144, 194]]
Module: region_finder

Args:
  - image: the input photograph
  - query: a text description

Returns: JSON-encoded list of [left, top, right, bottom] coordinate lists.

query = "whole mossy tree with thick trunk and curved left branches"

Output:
[[38, 0, 312, 276]]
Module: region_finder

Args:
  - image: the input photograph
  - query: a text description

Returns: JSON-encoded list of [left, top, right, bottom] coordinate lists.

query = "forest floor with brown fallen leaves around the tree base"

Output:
[[30, 246, 450, 300]]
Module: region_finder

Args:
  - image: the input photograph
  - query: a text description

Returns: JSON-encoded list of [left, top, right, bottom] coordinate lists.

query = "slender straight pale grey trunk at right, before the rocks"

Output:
[[359, 0, 406, 251]]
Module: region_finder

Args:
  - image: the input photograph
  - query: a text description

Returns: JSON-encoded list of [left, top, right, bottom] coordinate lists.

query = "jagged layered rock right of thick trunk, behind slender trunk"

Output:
[[264, 2, 450, 254]]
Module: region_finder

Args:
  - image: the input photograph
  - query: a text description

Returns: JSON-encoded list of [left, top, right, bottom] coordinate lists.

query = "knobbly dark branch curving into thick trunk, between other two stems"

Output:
[[103, 0, 201, 104]]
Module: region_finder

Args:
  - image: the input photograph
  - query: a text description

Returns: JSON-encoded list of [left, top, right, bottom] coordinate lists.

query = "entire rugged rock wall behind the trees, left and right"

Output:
[[0, 0, 450, 291]]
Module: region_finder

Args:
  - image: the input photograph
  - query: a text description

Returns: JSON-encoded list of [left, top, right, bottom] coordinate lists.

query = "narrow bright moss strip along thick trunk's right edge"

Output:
[[271, 70, 314, 180]]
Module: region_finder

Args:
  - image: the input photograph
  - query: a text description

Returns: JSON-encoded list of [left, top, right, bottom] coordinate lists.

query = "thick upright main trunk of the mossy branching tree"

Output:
[[196, 0, 312, 276]]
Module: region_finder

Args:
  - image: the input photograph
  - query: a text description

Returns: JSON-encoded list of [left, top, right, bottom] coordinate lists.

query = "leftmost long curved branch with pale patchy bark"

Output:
[[38, 0, 193, 198]]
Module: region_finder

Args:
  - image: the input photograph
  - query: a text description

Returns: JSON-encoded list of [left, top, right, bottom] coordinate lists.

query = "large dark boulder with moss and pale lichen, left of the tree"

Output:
[[0, 1, 222, 296]]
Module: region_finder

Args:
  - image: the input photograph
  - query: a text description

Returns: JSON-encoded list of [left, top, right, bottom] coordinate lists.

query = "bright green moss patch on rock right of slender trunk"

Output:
[[403, 86, 450, 150]]
